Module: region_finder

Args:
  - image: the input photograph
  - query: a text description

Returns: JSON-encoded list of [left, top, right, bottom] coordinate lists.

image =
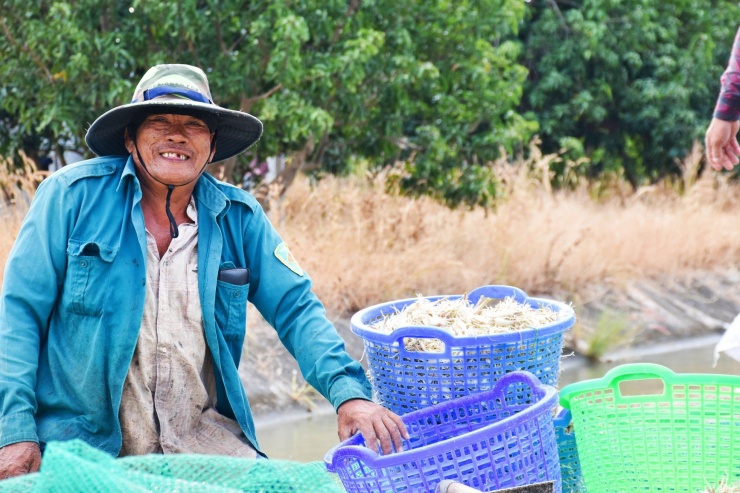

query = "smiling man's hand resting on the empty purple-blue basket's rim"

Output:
[[337, 399, 409, 455]]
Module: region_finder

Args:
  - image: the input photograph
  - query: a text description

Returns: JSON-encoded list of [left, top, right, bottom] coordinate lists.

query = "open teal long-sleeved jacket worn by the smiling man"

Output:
[[0, 157, 371, 455]]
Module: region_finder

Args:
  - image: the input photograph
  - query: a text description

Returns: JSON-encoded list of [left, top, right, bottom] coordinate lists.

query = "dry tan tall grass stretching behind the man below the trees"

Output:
[[0, 142, 740, 313]]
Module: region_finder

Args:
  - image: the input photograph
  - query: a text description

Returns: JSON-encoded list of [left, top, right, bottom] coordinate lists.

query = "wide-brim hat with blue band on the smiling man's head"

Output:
[[85, 64, 262, 162]]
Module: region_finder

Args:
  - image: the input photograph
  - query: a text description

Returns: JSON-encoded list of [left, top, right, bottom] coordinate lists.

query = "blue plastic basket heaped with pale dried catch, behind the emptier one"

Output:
[[351, 286, 575, 415]]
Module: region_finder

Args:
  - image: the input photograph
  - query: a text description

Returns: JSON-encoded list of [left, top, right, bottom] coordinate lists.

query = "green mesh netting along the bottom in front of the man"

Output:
[[0, 440, 344, 493]]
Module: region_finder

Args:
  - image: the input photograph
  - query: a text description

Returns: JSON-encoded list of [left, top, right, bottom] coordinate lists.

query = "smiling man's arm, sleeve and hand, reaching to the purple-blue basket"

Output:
[[244, 205, 407, 453]]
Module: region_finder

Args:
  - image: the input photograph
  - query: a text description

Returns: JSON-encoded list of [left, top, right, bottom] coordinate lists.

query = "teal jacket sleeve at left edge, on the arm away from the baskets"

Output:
[[0, 177, 69, 447]]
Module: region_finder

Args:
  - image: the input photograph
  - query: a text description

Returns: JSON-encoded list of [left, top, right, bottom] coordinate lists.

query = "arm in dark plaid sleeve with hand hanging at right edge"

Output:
[[705, 28, 740, 170]]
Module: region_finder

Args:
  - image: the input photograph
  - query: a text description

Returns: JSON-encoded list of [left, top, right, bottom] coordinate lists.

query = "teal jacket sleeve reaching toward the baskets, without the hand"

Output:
[[244, 207, 372, 409]]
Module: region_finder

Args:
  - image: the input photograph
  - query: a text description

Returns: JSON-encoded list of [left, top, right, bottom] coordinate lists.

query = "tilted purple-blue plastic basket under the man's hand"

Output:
[[324, 371, 561, 493]]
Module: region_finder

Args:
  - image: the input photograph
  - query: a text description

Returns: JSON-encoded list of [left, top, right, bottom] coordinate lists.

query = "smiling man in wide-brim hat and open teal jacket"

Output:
[[0, 65, 407, 478]]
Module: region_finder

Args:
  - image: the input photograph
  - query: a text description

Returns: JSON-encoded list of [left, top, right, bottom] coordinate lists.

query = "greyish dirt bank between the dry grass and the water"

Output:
[[241, 268, 740, 415]]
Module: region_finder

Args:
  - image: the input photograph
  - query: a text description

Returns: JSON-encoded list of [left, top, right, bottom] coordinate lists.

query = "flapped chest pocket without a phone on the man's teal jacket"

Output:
[[65, 238, 118, 317]]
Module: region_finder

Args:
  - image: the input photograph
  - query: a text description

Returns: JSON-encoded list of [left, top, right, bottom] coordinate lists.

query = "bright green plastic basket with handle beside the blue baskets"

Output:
[[560, 364, 740, 493]]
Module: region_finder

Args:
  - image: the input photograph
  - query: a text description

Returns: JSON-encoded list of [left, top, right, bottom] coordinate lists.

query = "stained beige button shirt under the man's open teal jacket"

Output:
[[119, 198, 257, 458]]
